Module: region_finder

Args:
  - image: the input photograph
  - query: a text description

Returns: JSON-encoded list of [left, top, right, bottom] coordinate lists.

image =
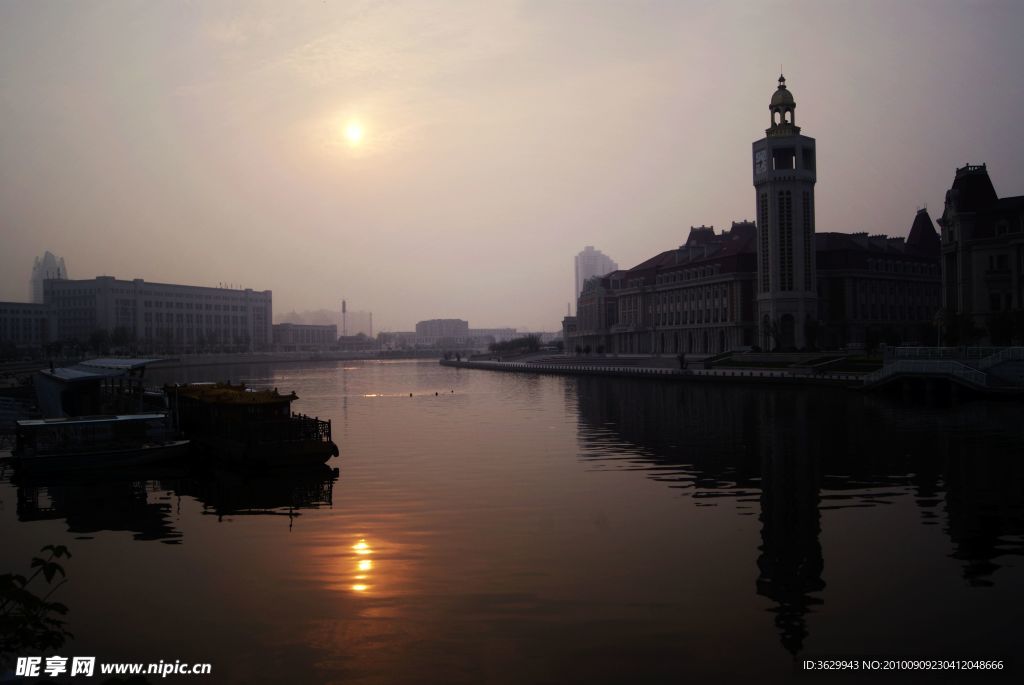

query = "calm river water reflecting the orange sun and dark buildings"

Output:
[[0, 360, 1024, 683]]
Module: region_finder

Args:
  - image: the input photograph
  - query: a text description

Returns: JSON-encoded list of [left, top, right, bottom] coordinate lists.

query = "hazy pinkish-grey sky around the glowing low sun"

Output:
[[0, 0, 1024, 330]]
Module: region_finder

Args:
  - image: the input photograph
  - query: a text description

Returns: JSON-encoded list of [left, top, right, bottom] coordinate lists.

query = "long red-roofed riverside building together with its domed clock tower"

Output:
[[563, 77, 941, 354]]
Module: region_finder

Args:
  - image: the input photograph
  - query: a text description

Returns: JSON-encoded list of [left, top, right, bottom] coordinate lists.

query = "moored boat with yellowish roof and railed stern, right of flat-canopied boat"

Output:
[[164, 383, 338, 466]]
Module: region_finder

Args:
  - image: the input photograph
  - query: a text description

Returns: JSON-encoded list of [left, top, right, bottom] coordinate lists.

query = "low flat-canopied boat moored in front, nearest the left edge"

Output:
[[11, 414, 188, 469]]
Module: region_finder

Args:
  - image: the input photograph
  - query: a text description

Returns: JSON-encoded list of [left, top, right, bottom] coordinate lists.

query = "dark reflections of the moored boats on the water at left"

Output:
[[7, 456, 338, 544]]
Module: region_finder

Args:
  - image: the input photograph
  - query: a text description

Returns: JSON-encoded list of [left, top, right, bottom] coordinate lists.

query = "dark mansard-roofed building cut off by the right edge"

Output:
[[939, 164, 1024, 344]]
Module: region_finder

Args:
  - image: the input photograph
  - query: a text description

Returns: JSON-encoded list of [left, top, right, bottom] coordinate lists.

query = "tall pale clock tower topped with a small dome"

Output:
[[754, 76, 818, 350]]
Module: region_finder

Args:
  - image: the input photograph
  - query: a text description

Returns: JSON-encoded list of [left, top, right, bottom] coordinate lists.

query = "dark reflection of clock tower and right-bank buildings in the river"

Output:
[[566, 378, 1024, 655]]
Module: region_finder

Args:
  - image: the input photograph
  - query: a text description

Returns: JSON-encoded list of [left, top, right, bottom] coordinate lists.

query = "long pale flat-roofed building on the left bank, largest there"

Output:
[[43, 276, 273, 351]]
